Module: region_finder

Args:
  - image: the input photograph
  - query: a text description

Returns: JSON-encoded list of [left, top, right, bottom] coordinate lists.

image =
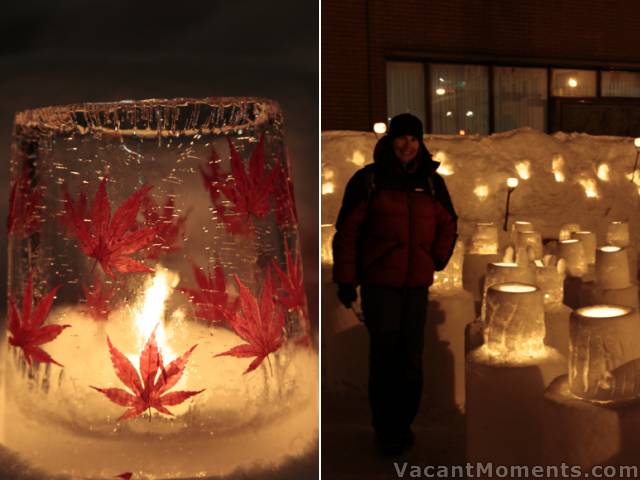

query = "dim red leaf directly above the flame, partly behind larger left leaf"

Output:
[[142, 195, 187, 260]]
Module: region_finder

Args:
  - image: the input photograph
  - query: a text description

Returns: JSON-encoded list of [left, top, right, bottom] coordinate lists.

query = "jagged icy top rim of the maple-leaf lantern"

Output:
[[14, 97, 284, 137]]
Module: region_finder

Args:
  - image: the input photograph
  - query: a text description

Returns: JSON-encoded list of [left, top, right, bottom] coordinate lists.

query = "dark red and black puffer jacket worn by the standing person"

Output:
[[333, 138, 457, 287]]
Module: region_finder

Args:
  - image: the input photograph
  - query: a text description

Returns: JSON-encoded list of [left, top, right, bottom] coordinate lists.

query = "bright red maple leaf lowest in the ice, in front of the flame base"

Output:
[[91, 327, 204, 420]]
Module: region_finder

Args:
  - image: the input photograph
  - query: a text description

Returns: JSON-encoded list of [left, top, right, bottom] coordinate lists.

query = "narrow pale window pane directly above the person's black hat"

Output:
[[387, 62, 426, 125]]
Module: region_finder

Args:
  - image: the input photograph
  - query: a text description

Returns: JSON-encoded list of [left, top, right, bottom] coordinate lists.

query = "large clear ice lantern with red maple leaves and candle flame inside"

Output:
[[6, 98, 317, 478]]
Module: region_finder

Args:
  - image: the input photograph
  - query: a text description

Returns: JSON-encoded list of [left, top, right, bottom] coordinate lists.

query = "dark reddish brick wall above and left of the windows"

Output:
[[321, 0, 640, 130]]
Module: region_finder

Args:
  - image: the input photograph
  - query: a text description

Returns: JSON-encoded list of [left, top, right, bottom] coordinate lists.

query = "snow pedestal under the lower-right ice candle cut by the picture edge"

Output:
[[543, 375, 640, 469]]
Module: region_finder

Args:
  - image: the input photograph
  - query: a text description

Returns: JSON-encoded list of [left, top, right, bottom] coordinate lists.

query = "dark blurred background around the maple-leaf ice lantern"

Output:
[[0, 0, 319, 331]]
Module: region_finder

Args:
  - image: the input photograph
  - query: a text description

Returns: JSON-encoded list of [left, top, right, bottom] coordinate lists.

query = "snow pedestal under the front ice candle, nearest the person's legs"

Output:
[[466, 347, 567, 465]]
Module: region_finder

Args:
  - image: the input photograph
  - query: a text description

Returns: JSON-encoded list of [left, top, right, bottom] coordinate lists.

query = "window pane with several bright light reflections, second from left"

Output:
[[429, 64, 489, 134]]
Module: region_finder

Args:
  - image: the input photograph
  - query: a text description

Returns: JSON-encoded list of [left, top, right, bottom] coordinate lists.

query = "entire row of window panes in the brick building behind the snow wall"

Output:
[[387, 60, 640, 135]]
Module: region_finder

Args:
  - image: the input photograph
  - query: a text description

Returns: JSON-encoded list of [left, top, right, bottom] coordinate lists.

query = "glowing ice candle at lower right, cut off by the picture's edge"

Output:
[[569, 305, 640, 401]]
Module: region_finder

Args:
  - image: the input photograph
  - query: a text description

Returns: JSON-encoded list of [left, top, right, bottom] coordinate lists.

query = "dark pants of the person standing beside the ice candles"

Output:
[[361, 285, 428, 435]]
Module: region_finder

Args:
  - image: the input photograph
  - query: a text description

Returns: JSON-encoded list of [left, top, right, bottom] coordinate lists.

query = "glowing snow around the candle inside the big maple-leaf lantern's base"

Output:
[[5, 308, 318, 478]]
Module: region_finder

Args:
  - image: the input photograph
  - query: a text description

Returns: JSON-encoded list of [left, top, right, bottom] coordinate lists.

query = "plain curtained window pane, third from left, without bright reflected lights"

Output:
[[493, 67, 547, 132]]
